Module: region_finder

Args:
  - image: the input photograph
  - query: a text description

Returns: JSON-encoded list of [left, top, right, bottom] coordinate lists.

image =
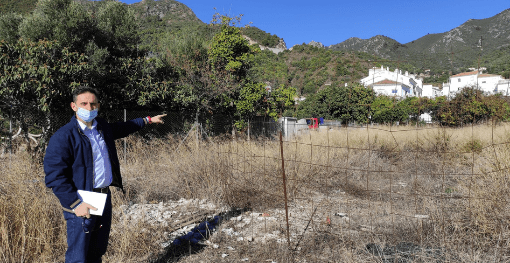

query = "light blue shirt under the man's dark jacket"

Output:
[[77, 120, 113, 188]]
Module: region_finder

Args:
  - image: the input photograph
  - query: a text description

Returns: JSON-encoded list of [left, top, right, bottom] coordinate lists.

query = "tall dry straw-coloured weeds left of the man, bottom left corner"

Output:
[[0, 152, 65, 262]]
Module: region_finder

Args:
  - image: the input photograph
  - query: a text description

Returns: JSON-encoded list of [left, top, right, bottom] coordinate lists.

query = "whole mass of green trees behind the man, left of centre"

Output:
[[0, 0, 295, 145]]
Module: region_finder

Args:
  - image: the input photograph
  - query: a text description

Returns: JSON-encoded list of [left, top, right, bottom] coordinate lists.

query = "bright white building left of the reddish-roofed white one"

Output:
[[360, 66, 423, 97]]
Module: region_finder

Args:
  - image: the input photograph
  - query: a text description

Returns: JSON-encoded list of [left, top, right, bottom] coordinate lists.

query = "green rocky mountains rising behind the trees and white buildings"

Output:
[[0, 0, 510, 88]]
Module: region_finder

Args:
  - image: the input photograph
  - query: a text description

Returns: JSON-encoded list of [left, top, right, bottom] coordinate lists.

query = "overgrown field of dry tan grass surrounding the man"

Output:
[[0, 123, 510, 262]]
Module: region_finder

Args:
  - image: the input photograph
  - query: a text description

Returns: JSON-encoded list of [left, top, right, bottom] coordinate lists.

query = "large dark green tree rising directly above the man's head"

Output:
[[15, 0, 162, 110]]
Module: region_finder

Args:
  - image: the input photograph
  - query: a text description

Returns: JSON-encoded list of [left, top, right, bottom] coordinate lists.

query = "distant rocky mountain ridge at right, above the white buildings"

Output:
[[328, 9, 510, 75]]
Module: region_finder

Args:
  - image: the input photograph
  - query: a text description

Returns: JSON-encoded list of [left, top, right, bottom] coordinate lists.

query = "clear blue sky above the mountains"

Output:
[[121, 0, 510, 48]]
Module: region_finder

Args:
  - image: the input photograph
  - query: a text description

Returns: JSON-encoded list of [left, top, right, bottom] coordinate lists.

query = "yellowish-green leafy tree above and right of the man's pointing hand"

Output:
[[160, 14, 295, 129]]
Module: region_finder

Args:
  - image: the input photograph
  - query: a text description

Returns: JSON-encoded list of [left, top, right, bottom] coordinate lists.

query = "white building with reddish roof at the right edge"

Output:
[[443, 71, 509, 98]]
